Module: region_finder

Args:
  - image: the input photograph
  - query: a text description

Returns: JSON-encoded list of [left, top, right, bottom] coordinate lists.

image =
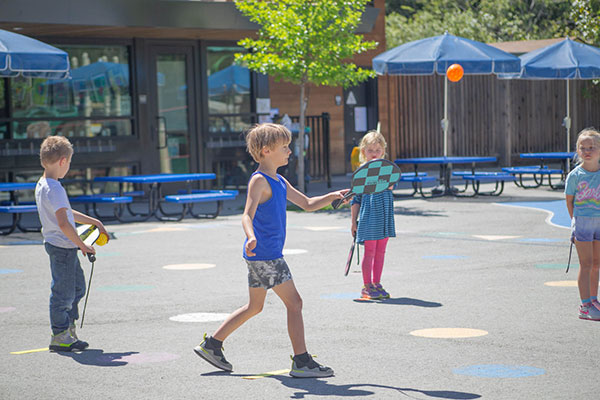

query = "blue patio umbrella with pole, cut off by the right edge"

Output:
[[500, 38, 600, 151]]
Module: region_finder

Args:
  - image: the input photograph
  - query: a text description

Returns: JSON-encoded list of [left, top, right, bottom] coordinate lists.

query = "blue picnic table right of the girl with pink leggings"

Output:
[[394, 156, 497, 197]]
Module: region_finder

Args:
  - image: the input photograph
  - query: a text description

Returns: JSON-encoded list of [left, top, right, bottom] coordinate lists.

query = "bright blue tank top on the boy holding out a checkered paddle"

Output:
[[242, 171, 287, 260]]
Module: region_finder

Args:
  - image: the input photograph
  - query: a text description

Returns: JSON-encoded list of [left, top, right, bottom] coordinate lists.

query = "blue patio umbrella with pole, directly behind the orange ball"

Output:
[[373, 32, 521, 156]]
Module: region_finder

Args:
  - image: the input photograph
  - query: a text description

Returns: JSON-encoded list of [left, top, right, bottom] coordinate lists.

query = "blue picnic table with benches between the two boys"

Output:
[[71, 173, 238, 222]]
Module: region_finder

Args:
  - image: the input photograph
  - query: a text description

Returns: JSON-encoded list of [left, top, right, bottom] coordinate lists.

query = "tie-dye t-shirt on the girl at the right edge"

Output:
[[565, 165, 600, 217]]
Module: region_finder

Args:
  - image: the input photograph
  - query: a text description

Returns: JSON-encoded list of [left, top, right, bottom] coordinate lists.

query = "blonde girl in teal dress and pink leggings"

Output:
[[351, 131, 396, 299]]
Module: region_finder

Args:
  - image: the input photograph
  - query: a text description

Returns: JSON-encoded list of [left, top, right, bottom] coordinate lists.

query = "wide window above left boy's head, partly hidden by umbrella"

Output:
[[0, 45, 132, 139]]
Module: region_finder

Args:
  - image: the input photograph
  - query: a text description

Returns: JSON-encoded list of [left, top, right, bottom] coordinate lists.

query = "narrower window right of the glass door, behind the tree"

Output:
[[207, 46, 252, 138]]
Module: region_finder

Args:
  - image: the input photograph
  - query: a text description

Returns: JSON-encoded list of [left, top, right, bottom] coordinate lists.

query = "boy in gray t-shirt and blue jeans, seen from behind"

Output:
[[35, 136, 108, 351]]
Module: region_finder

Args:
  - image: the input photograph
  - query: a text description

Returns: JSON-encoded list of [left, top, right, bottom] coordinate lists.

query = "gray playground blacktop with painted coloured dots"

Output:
[[0, 177, 600, 399]]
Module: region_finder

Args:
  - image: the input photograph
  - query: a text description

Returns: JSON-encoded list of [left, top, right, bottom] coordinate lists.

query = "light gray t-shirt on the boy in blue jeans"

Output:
[[35, 177, 77, 249]]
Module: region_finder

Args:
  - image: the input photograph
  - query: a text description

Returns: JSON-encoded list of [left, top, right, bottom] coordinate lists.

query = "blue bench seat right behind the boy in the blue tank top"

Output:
[[162, 190, 238, 221]]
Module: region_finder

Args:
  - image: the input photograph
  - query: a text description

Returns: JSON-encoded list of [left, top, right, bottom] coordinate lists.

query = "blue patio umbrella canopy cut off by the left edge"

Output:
[[0, 29, 69, 79]]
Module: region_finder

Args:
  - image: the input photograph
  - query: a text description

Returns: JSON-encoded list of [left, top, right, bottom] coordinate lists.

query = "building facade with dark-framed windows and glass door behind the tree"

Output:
[[0, 0, 385, 186]]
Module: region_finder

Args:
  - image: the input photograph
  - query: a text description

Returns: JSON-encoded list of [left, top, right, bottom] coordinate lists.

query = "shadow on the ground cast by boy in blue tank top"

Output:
[[270, 375, 481, 400]]
